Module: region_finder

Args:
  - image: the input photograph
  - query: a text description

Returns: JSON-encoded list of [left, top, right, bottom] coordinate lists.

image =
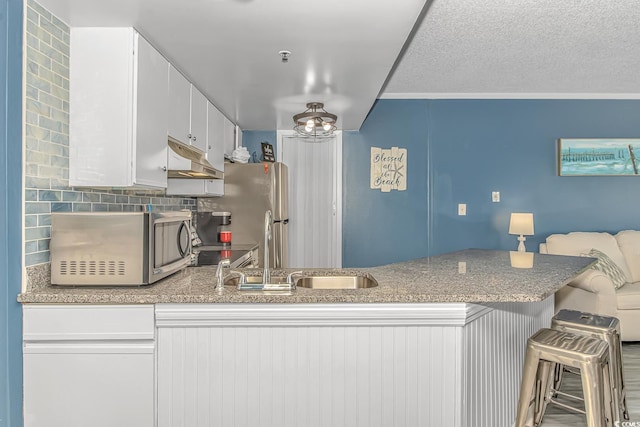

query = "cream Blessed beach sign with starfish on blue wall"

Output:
[[370, 147, 407, 193]]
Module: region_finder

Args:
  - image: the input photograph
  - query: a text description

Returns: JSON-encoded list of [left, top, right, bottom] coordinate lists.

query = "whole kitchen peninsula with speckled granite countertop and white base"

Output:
[[19, 249, 595, 427]]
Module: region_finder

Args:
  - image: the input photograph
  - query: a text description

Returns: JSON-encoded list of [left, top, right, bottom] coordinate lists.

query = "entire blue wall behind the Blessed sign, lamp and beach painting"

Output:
[[343, 100, 640, 267]]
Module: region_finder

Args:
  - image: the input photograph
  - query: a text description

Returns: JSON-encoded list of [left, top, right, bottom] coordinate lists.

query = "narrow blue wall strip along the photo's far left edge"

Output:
[[0, 0, 22, 427]]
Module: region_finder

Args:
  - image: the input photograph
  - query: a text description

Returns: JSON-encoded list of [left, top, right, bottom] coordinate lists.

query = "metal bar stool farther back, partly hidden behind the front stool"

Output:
[[551, 310, 629, 422]]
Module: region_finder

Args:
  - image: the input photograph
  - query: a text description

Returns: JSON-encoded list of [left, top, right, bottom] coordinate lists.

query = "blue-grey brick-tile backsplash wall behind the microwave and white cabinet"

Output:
[[24, 0, 196, 267]]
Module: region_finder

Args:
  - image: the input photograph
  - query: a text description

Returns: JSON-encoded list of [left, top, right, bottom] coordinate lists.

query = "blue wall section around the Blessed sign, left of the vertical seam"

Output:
[[342, 101, 429, 267]]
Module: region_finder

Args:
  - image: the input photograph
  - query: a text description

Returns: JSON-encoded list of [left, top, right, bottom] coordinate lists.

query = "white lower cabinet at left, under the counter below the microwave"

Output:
[[23, 304, 155, 427]]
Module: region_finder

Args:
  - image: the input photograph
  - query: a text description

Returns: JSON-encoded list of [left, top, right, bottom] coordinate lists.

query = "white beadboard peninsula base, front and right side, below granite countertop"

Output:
[[156, 299, 553, 427]]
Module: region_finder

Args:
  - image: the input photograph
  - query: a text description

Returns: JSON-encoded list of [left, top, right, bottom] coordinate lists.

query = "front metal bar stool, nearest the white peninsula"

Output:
[[515, 328, 613, 427]]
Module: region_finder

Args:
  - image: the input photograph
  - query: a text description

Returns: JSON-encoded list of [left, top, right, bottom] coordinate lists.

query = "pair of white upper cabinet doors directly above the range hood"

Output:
[[168, 66, 208, 152]]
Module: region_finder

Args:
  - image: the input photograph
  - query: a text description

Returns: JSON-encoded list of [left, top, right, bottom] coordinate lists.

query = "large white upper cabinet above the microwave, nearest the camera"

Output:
[[69, 28, 169, 188]]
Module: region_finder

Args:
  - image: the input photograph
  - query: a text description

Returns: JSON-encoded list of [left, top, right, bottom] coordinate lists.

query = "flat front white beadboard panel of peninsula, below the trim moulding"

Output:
[[158, 327, 459, 427]]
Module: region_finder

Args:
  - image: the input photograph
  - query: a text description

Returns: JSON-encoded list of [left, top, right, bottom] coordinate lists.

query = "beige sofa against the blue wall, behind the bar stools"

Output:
[[540, 230, 640, 341]]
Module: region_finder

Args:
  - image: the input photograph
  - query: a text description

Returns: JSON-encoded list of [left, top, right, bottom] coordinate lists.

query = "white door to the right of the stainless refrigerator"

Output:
[[276, 131, 342, 268]]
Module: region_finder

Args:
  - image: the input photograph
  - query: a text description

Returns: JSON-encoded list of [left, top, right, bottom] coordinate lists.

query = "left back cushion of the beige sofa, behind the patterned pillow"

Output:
[[547, 231, 634, 282]]
